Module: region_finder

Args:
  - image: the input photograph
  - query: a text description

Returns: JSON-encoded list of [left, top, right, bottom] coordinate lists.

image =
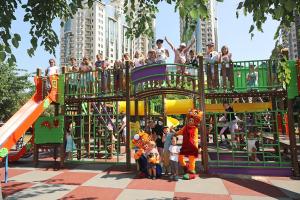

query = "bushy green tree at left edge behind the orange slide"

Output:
[[0, 63, 33, 121]]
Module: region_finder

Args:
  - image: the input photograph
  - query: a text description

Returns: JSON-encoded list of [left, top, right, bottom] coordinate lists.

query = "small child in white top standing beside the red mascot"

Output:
[[169, 135, 180, 181]]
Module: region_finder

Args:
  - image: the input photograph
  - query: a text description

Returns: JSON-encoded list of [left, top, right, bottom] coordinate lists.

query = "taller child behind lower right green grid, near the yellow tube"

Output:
[[220, 98, 239, 145]]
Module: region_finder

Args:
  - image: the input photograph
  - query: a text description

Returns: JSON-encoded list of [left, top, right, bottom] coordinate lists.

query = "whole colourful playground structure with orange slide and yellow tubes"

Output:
[[0, 57, 300, 176]]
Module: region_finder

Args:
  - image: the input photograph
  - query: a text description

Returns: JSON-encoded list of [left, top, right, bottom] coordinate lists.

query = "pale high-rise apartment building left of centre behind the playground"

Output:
[[60, 0, 153, 65]]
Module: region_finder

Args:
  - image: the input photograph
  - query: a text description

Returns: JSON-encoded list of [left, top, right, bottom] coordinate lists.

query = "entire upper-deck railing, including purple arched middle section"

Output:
[[65, 60, 295, 98]]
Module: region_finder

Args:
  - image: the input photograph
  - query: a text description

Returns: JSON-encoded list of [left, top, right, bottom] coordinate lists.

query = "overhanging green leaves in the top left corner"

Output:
[[0, 0, 95, 65]]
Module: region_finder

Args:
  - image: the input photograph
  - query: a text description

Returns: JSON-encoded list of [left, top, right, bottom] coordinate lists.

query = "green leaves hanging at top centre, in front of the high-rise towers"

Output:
[[124, 0, 223, 40]]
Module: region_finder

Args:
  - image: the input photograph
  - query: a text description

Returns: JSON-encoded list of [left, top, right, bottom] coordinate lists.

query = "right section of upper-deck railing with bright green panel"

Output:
[[204, 60, 283, 92]]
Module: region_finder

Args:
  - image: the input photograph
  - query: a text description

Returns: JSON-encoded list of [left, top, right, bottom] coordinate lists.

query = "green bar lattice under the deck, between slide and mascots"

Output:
[[65, 103, 126, 163]]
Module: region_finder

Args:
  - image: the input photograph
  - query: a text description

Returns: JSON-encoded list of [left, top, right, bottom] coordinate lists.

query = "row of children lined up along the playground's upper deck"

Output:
[[46, 37, 258, 93]]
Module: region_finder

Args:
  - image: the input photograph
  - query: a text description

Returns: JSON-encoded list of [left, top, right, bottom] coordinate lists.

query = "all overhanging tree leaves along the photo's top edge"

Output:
[[0, 0, 300, 64]]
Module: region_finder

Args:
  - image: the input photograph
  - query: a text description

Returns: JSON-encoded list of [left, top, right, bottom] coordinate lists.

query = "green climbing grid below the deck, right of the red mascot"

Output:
[[206, 110, 290, 168]]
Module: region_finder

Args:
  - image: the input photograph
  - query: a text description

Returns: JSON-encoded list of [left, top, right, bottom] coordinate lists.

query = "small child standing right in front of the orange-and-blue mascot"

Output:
[[145, 141, 159, 180]]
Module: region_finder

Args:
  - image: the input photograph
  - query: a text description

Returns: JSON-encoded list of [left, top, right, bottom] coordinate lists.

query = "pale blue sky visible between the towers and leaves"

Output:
[[12, 0, 279, 72]]
